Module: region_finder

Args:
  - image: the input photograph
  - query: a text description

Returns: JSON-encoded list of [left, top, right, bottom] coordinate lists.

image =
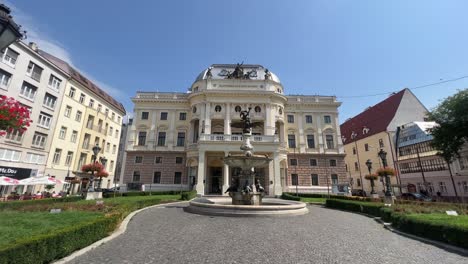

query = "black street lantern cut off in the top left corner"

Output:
[[0, 4, 26, 50]]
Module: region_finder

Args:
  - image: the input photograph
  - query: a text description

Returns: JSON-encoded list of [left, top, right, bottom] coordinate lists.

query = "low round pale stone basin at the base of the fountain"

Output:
[[184, 197, 309, 217]]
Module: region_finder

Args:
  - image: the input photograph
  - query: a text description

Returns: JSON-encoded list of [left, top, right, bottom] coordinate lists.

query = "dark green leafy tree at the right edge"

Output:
[[429, 89, 468, 163]]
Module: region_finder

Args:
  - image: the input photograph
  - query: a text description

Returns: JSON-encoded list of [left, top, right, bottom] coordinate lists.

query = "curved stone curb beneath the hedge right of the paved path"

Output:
[[324, 206, 468, 256]]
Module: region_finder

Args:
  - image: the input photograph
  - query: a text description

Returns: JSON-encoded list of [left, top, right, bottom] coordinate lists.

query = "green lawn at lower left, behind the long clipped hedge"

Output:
[[0, 211, 103, 248]]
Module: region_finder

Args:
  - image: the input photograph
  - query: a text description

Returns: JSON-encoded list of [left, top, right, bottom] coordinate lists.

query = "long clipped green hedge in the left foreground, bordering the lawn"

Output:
[[0, 215, 120, 264]]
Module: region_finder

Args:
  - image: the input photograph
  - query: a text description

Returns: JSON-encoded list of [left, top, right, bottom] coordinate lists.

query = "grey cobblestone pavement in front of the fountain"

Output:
[[70, 204, 468, 264]]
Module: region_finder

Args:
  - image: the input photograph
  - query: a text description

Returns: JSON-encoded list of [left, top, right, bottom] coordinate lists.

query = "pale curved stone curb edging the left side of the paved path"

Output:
[[52, 201, 188, 264]]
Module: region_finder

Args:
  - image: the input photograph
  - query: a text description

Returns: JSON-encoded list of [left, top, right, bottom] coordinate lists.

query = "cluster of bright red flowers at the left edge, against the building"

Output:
[[0, 95, 32, 136]]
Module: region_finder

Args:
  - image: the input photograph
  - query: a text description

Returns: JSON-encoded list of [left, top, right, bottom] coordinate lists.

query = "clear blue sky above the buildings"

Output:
[[6, 0, 468, 122]]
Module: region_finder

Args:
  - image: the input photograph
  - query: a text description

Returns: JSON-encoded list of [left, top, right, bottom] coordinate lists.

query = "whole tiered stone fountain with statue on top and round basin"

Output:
[[184, 108, 309, 216]]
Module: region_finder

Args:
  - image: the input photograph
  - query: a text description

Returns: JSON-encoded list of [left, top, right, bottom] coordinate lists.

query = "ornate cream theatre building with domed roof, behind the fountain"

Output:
[[120, 64, 348, 196]]
